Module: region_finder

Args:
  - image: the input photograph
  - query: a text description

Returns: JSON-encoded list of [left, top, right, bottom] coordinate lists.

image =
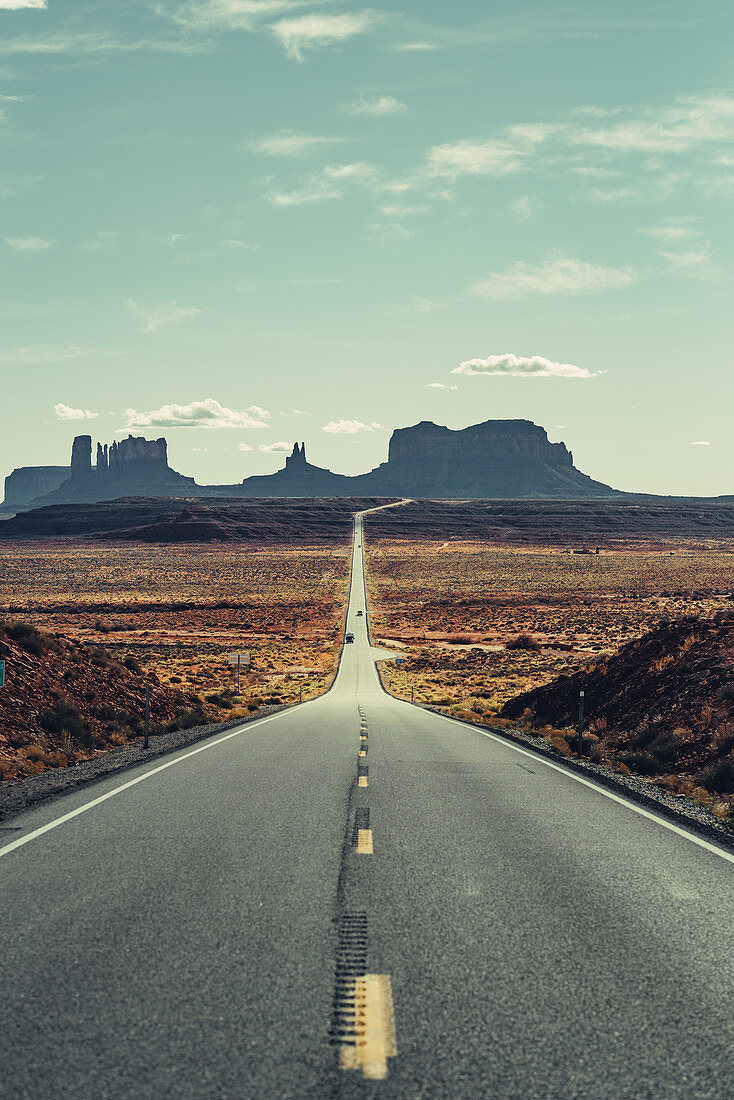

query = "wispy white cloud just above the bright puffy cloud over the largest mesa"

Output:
[[472, 253, 637, 301]]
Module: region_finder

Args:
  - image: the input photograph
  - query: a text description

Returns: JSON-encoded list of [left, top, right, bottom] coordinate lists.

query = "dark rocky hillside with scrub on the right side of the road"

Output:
[[501, 612, 734, 809]]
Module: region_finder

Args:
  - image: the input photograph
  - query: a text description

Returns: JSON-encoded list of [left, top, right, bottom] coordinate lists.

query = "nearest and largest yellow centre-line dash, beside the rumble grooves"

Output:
[[339, 974, 397, 1081]]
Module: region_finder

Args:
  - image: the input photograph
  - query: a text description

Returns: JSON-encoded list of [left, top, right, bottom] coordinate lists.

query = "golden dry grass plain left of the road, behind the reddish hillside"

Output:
[[0, 542, 349, 734]]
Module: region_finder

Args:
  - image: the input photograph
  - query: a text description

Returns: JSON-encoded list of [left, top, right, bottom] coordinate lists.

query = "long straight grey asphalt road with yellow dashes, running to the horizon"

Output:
[[0, 510, 734, 1100]]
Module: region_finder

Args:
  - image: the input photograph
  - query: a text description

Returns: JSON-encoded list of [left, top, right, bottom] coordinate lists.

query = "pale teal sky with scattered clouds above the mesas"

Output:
[[0, 0, 734, 494]]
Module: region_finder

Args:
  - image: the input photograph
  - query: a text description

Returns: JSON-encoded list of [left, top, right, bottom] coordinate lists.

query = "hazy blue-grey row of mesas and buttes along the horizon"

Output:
[[2, 420, 622, 512]]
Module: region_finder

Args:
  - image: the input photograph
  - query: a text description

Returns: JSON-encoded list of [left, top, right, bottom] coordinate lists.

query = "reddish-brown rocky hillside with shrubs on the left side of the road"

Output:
[[0, 622, 218, 780]]
